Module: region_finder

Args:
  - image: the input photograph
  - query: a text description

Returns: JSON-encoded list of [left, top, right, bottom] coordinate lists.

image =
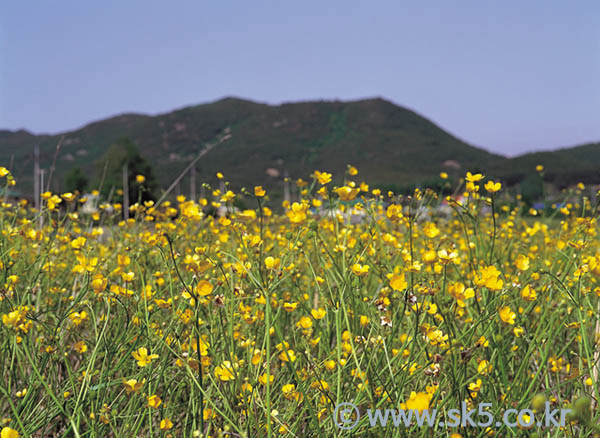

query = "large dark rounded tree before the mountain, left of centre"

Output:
[[98, 137, 157, 203]]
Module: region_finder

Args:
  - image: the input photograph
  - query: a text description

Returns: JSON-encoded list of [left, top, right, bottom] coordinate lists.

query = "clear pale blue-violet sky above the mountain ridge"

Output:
[[0, 0, 600, 155]]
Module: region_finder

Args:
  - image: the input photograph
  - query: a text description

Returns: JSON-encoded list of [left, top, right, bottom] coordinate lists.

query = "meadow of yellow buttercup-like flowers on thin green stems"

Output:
[[0, 166, 600, 438]]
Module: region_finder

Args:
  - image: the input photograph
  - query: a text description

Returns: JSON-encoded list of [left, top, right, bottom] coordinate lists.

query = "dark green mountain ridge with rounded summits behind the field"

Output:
[[0, 98, 600, 196]]
